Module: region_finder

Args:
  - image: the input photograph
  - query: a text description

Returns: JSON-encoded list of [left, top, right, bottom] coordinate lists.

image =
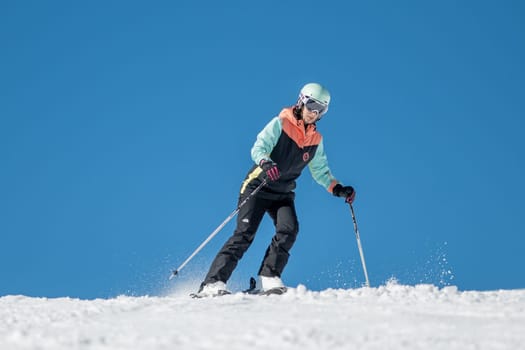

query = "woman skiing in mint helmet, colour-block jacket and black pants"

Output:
[[197, 83, 355, 297]]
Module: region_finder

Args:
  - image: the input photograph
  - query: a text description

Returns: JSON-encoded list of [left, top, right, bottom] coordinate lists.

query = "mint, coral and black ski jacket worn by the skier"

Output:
[[241, 107, 338, 195]]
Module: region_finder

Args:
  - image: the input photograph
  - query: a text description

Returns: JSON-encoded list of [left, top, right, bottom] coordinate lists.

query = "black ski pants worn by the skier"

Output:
[[203, 192, 299, 285]]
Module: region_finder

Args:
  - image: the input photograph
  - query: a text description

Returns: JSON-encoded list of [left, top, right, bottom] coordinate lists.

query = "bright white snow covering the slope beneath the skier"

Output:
[[0, 283, 525, 350]]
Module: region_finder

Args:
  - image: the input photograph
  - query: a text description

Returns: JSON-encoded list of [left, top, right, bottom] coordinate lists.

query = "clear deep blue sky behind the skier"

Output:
[[0, 1, 525, 298]]
